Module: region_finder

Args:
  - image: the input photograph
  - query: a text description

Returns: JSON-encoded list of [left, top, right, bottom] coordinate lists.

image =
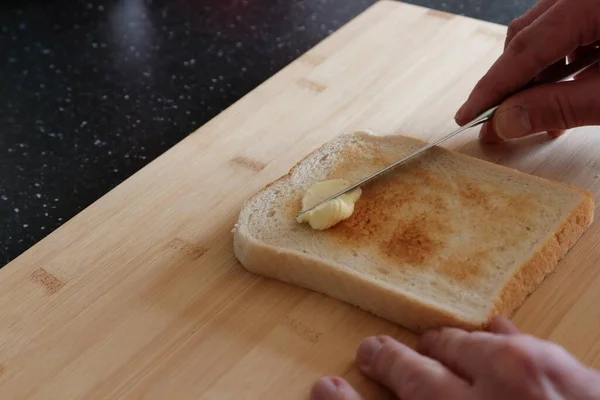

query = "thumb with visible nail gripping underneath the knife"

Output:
[[486, 77, 600, 139]]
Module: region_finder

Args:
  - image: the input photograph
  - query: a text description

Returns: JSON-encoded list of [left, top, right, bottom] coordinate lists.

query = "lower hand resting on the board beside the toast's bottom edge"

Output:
[[312, 318, 600, 400]]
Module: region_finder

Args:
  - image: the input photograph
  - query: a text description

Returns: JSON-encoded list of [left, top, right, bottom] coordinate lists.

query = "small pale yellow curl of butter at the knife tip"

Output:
[[296, 179, 362, 230]]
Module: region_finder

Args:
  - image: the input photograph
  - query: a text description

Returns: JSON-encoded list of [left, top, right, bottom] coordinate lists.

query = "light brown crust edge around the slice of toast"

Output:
[[233, 133, 594, 332]]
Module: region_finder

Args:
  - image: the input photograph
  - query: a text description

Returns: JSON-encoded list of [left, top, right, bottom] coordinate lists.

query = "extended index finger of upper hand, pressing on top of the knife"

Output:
[[455, 0, 600, 125]]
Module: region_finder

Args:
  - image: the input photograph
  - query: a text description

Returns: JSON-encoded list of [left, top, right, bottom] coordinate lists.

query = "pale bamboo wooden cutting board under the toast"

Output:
[[0, 1, 600, 400]]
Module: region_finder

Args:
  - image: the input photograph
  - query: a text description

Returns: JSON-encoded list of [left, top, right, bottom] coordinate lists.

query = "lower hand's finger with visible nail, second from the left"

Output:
[[357, 336, 468, 400]]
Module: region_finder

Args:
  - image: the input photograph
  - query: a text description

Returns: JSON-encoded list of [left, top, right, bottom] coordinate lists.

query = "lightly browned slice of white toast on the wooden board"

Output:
[[234, 132, 594, 332]]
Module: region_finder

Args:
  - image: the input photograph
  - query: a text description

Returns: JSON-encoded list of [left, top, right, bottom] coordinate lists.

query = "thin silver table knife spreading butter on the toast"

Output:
[[298, 46, 600, 216]]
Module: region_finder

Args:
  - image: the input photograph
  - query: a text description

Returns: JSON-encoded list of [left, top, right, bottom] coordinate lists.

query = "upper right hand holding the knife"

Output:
[[455, 0, 600, 142]]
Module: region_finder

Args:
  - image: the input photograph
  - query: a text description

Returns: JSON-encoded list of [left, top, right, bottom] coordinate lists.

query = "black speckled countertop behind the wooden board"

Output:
[[0, 0, 534, 267]]
